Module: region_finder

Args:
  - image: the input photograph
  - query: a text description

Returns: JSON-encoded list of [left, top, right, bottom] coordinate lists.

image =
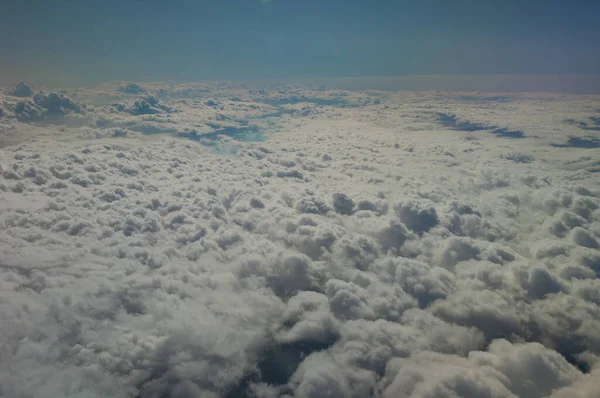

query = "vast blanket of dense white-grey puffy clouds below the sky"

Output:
[[0, 83, 600, 398]]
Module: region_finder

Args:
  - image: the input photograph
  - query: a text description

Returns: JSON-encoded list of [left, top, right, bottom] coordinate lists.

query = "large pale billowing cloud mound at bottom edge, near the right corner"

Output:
[[382, 340, 580, 398]]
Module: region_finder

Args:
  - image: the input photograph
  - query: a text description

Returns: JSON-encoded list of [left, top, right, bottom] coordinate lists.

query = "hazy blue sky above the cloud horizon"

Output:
[[0, 0, 600, 82]]
